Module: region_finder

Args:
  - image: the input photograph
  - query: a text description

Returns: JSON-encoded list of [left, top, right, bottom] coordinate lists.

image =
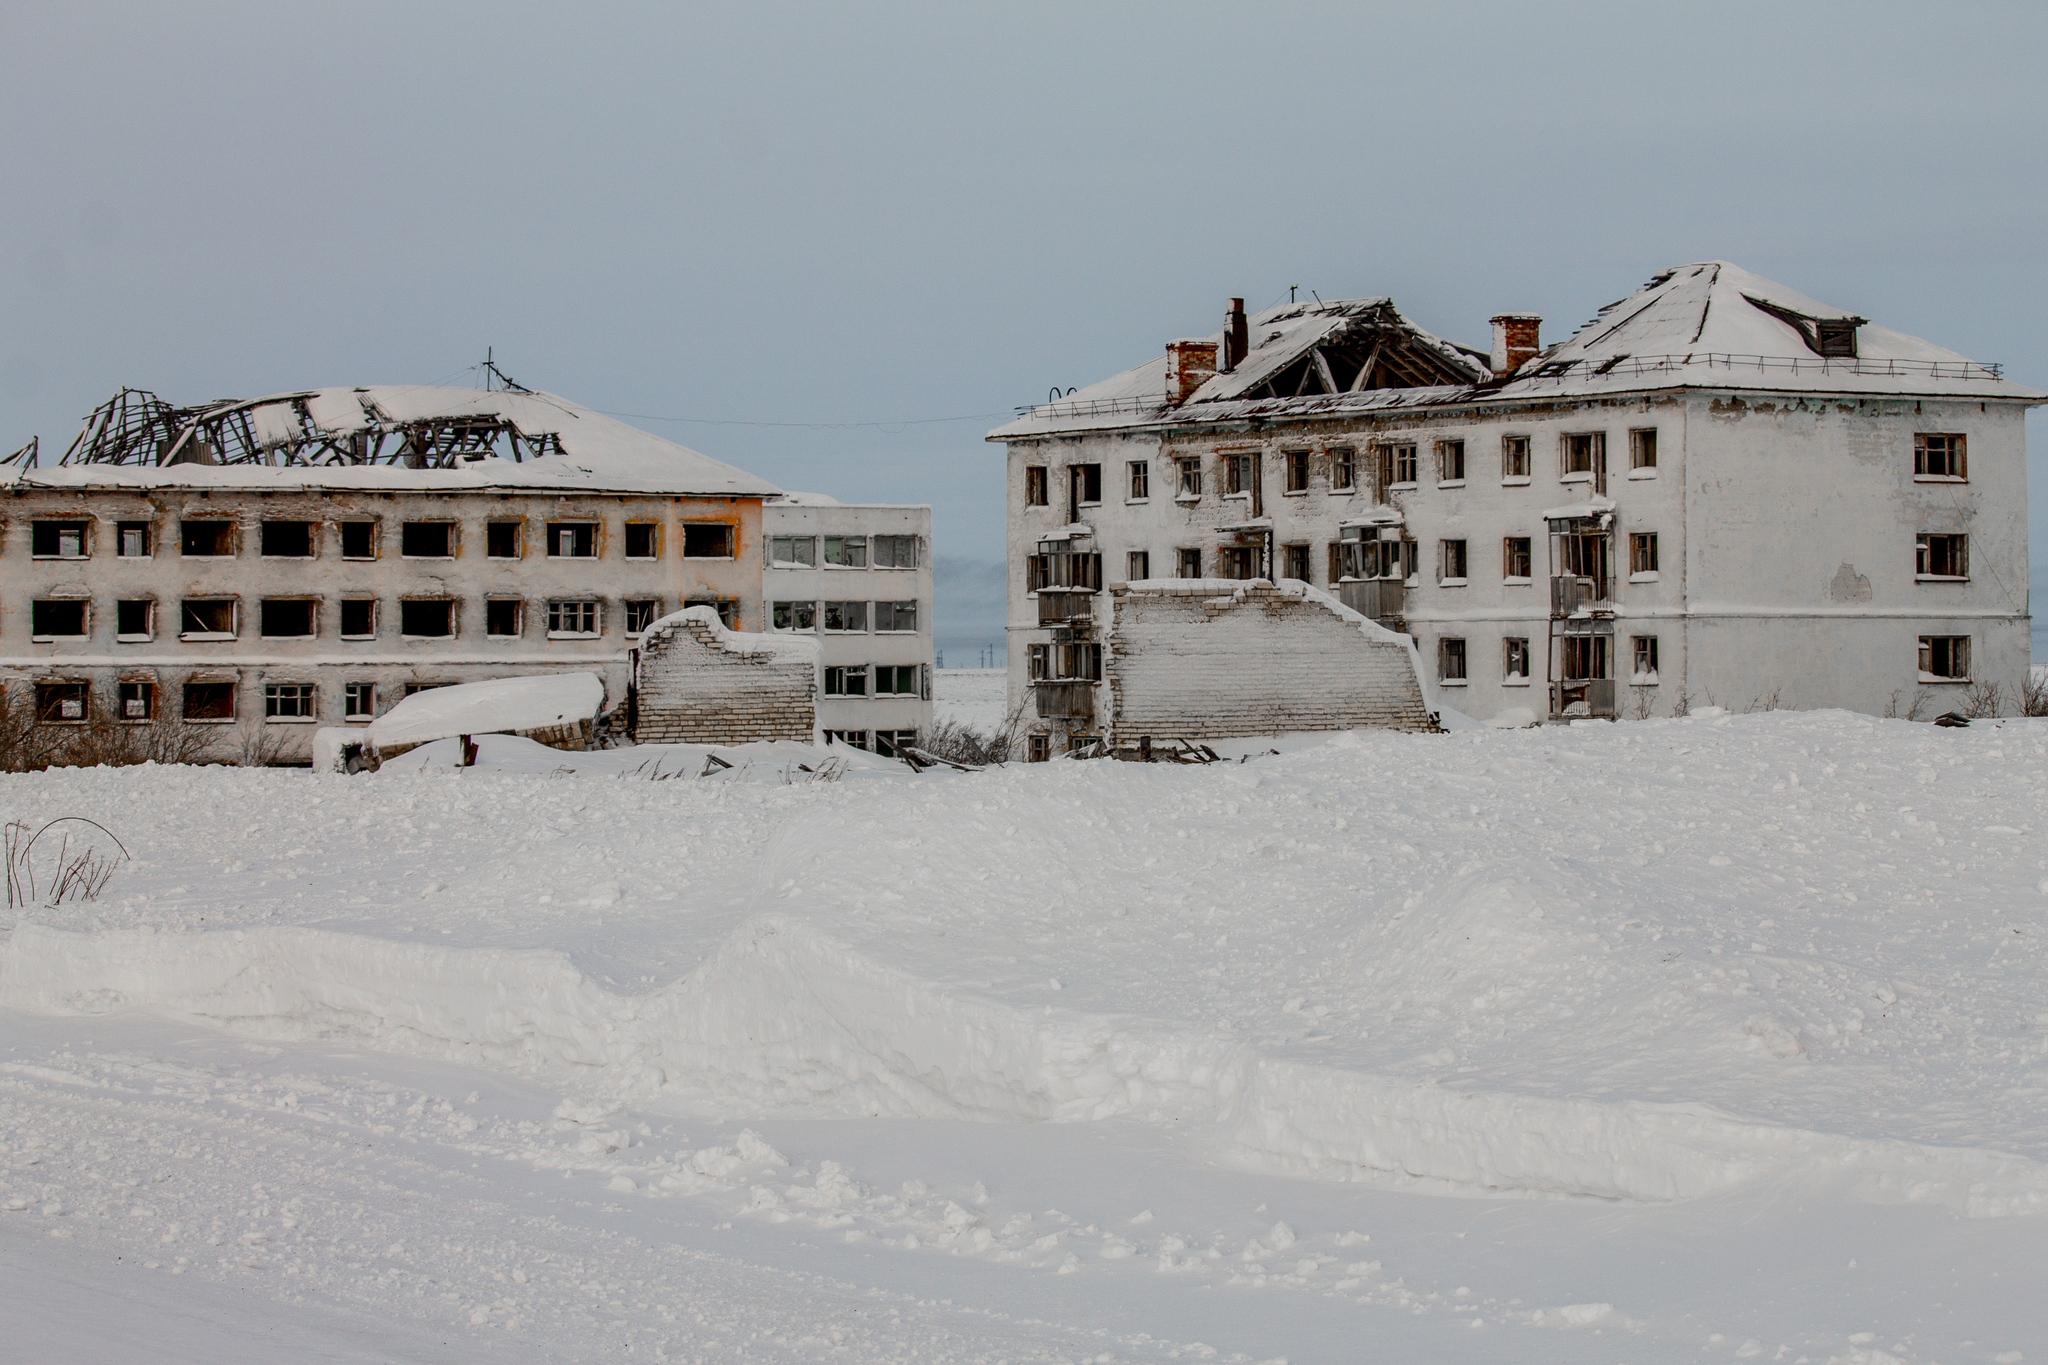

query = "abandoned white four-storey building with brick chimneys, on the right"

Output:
[[989, 262, 2044, 757]]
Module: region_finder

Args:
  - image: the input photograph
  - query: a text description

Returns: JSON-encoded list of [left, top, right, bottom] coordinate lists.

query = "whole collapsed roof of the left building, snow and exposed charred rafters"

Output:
[[8, 385, 780, 497]]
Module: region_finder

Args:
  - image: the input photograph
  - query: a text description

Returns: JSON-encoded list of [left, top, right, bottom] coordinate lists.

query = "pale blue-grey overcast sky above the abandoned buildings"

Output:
[[0, 0, 2048, 613]]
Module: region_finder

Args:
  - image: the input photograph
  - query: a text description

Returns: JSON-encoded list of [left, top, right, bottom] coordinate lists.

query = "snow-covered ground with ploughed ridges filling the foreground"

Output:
[[0, 699, 2048, 1365]]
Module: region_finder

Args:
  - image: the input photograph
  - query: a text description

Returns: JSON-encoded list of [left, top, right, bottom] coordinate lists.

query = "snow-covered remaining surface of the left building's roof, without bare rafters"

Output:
[[12, 385, 780, 497]]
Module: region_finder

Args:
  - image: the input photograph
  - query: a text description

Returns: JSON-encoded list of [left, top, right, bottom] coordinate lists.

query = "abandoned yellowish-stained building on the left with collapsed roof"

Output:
[[0, 387, 930, 761]]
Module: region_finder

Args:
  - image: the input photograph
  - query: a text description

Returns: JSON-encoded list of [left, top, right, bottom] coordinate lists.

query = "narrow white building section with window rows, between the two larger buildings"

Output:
[[762, 493, 932, 753]]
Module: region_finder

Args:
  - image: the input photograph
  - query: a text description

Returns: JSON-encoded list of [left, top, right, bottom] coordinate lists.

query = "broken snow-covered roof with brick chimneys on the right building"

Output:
[[989, 262, 2048, 440]]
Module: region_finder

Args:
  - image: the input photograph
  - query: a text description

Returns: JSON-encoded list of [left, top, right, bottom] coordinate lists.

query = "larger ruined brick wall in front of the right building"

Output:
[[1104, 579, 1430, 739]]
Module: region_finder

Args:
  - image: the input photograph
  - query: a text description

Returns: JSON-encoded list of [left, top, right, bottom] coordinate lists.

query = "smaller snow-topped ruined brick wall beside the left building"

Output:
[[633, 608, 817, 745]]
